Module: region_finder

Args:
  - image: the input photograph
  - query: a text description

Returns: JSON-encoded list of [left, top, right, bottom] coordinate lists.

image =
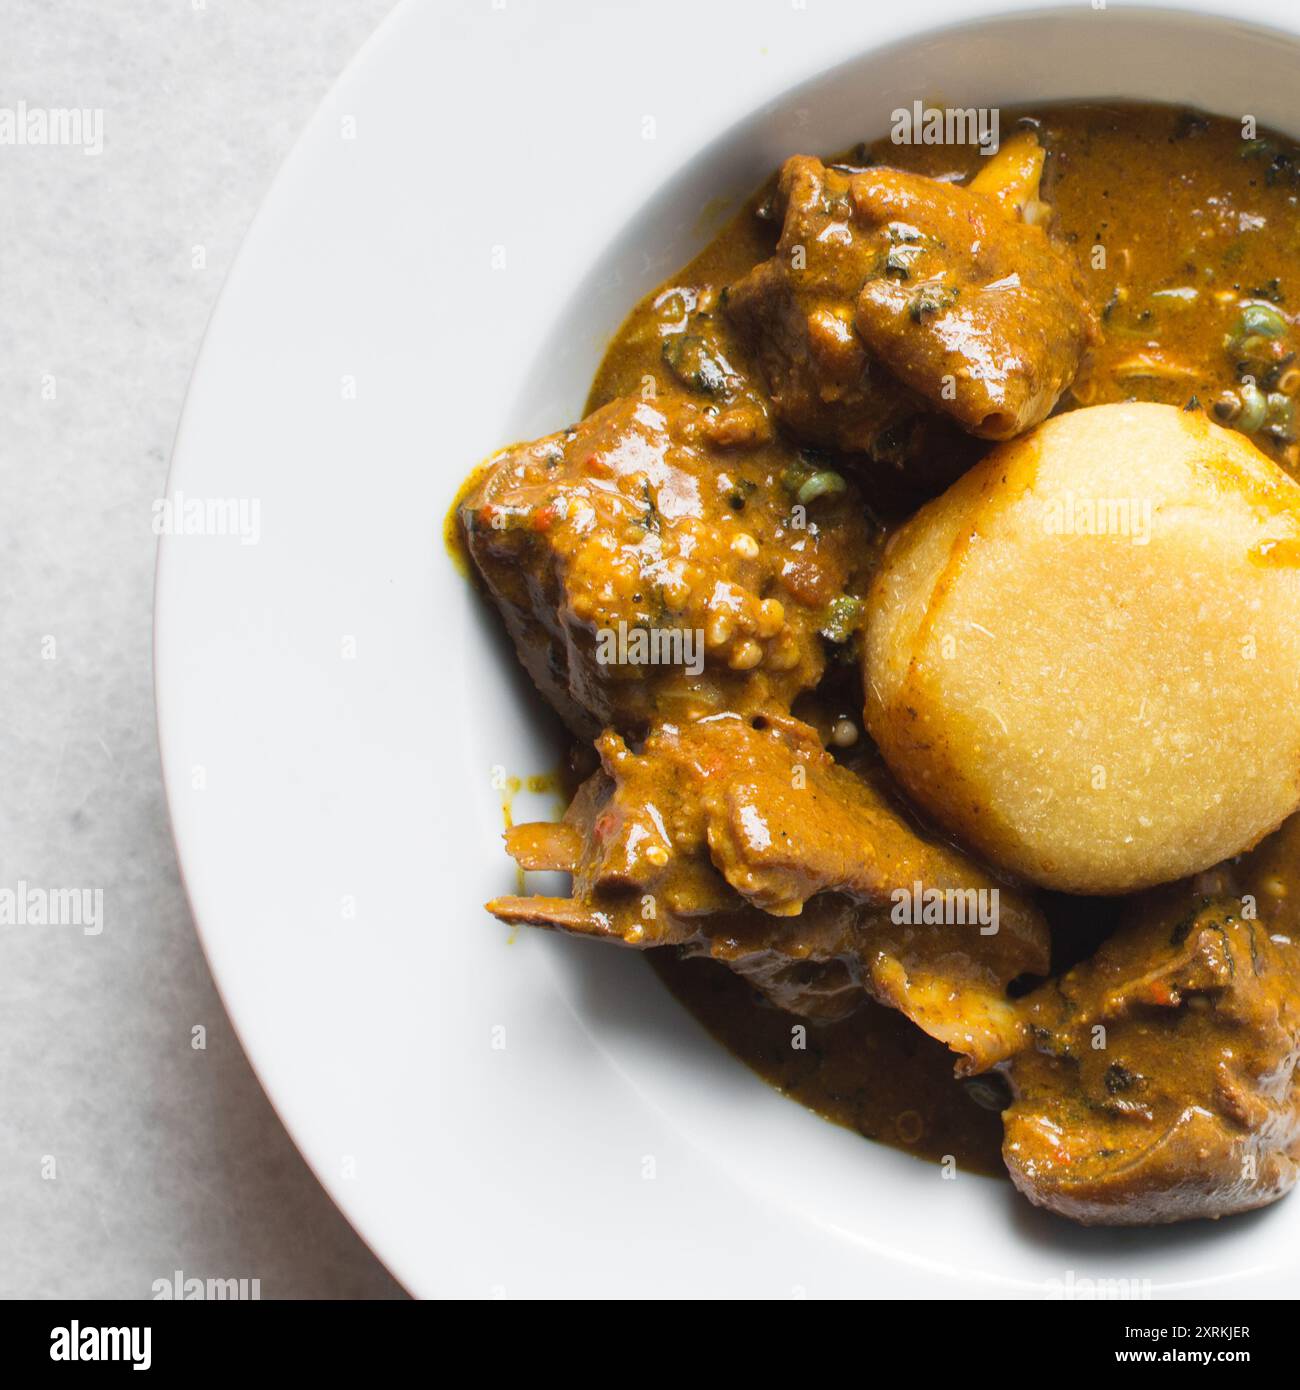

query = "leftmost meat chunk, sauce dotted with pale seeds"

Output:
[[459, 391, 879, 737]]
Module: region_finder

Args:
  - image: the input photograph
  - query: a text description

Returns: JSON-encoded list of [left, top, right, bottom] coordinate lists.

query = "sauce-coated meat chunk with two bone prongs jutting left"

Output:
[[488, 714, 1048, 1072]]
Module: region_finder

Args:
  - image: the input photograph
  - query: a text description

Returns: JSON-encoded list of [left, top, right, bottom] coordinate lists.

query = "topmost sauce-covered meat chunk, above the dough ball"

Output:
[[727, 144, 1097, 461]]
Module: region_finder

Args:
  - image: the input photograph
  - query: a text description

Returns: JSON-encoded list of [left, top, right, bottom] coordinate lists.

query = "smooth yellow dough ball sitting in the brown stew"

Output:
[[865, 404, 1300, 894]]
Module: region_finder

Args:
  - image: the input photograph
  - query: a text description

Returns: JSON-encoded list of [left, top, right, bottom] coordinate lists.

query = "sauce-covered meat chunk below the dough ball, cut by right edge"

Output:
[[1002, 817, 1300, 1226]]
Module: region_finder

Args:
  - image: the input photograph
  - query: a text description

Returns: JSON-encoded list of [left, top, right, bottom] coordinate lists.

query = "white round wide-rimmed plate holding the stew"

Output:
[[156, 0, 1300, 1298]]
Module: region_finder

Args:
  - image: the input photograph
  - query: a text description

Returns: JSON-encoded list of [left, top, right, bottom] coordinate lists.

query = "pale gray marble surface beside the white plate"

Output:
[[0, 0, 400, 1298]]
